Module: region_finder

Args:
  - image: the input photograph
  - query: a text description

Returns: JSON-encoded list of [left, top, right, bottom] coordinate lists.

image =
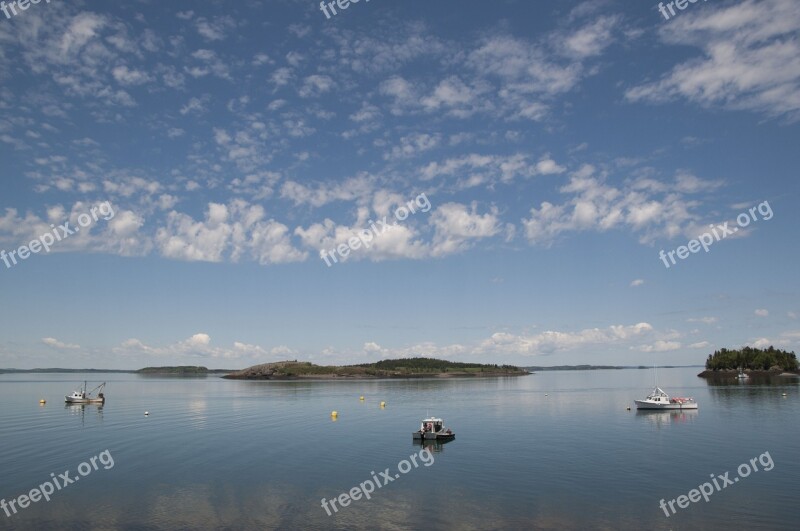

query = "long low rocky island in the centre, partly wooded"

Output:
[[223, 358, 530, 380]]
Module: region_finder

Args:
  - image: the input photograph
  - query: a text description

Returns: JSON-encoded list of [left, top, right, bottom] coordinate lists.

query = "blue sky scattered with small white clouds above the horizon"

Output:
[[0, 0, 800, 368]]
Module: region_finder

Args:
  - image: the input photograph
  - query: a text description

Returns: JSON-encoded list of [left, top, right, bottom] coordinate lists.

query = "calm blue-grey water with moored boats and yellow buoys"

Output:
[[0, 369, 800, 530]]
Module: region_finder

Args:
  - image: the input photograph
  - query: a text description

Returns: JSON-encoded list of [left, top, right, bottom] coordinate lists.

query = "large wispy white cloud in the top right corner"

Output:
[[626, 0, 800, 121]]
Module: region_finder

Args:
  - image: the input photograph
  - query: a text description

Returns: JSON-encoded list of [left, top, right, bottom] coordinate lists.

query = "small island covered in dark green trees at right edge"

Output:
[[698, 346, 800, 378]]
